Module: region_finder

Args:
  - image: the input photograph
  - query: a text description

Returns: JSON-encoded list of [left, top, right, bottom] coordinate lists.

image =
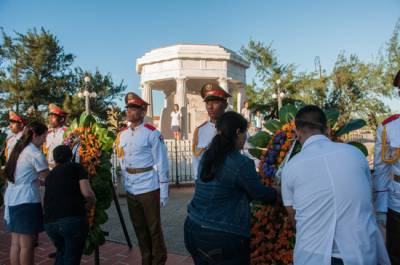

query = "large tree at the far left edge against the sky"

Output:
[[0, 28, 74, 112]]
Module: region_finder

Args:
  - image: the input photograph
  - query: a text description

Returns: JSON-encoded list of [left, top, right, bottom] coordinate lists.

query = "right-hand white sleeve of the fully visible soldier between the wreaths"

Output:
[[151, 131, 168, 198]]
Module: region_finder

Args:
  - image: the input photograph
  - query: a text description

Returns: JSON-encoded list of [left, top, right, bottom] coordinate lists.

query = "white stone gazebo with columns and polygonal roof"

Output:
[[136, 44, 249, 139]]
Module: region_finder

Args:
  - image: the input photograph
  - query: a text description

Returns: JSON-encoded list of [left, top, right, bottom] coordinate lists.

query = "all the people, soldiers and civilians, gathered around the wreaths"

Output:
[[0, 71, 400, 265]]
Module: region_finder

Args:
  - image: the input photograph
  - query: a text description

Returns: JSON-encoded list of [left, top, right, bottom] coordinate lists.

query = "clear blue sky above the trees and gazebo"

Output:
[[0, 0, 400, 114]]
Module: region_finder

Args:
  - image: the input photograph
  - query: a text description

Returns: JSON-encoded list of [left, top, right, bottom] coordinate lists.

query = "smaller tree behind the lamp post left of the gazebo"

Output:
[[63, 68, 126, 123]]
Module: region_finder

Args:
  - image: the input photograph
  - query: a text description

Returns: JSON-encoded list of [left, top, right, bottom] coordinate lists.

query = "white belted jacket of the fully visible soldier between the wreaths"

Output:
[[116, 123, 168, 199]]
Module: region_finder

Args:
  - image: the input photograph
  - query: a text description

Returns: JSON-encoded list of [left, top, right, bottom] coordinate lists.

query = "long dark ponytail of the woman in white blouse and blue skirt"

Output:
[[4, 121, 47, 183]]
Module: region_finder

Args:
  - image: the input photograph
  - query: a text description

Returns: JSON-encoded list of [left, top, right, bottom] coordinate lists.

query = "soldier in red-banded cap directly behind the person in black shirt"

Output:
[[43, 104, 67, 169]]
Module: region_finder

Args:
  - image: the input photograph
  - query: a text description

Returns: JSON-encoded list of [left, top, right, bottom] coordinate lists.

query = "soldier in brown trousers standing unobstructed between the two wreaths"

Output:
[[116, 92, 168, 265]]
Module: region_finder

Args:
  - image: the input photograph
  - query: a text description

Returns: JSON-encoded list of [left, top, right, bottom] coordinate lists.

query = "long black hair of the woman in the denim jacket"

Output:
[[200, 111, 247, 182]]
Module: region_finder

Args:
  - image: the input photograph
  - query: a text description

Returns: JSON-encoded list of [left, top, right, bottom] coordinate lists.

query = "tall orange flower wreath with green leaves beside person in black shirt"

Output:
[[64, 114, 114, 255]]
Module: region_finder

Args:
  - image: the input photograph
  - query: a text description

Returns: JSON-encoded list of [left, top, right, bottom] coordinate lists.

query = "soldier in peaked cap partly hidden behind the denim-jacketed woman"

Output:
[[192, 83, 231, 179]]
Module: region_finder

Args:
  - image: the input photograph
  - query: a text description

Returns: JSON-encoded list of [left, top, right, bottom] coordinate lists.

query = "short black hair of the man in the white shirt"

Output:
[[294, 105, 328, 133]]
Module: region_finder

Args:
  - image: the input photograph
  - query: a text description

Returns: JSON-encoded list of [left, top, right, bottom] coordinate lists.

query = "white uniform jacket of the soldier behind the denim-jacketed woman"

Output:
[[192, 121, 217, 180]]
